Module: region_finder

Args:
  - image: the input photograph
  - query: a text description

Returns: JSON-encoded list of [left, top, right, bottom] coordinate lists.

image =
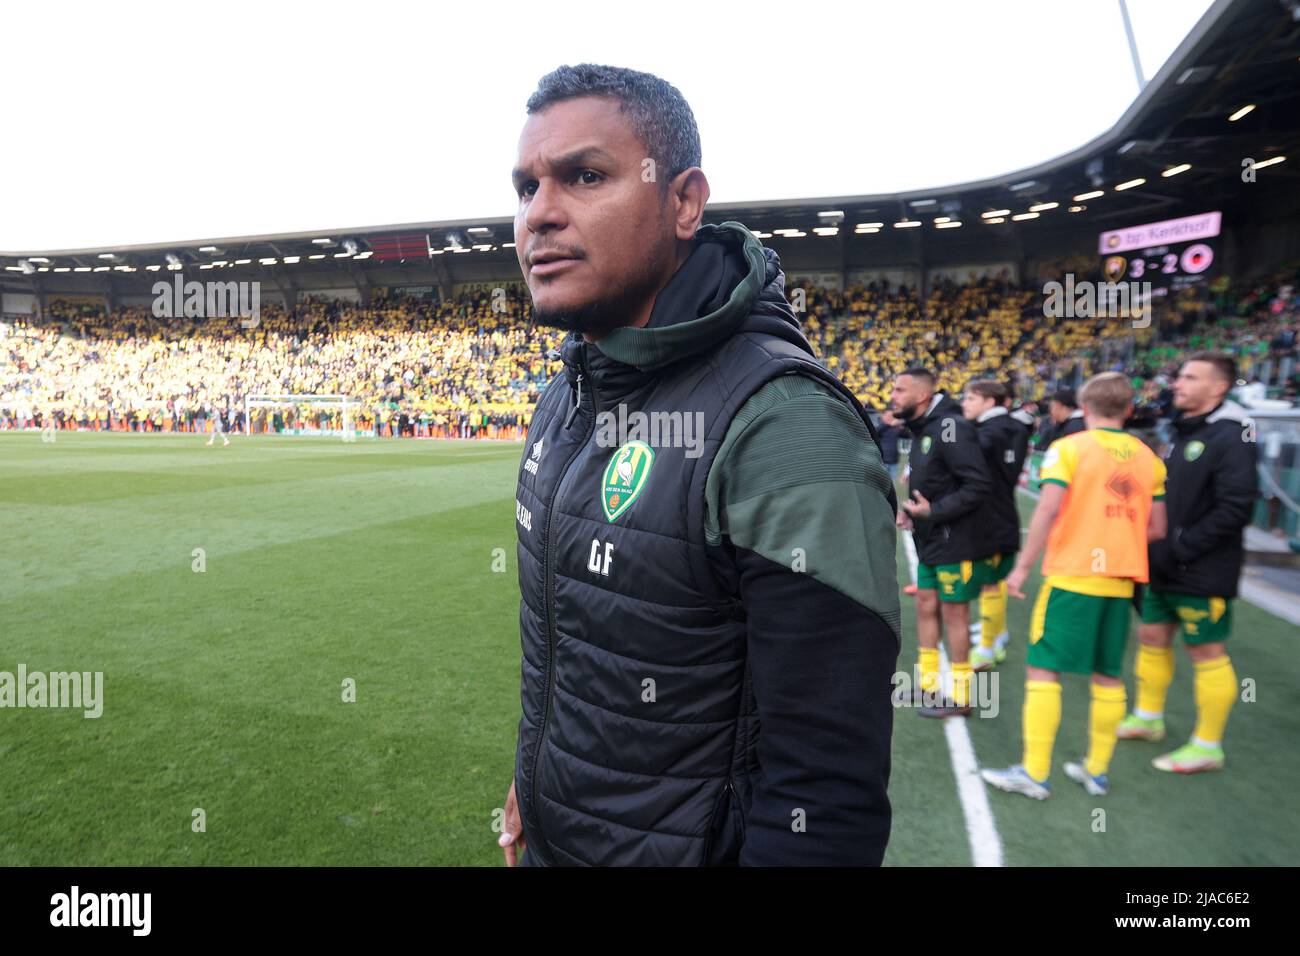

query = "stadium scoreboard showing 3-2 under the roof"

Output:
[[1099, 212, 1223, 295]]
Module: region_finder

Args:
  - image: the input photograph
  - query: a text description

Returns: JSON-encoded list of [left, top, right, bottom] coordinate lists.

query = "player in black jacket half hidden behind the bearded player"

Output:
[[962, 378, 1030, 671]]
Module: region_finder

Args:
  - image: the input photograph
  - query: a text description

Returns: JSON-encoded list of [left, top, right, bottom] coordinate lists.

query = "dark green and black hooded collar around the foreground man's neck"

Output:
[[559, 221, 813, 406]]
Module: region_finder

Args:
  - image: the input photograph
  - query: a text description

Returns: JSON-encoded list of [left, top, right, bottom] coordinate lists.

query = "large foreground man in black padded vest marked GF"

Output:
[[499, 64, 898, 866]]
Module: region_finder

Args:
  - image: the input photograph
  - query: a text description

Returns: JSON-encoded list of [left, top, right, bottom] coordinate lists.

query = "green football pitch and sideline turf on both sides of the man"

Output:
[[0, 433, 1300, 866]]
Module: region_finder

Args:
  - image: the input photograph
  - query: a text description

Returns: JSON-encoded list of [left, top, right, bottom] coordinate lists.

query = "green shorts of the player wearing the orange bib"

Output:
[[1024, 584, 1132, 678]]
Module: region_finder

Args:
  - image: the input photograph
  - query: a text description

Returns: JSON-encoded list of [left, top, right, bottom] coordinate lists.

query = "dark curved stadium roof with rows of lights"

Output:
[[0, 0, 1300, 291]]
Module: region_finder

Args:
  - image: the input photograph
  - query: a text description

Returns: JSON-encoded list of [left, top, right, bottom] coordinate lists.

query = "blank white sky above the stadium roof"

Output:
[[0, 0, 1210, 251]]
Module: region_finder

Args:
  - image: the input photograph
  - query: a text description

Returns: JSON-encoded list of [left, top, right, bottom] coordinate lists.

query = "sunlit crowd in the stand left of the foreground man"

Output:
[[0, 293, 559, 437]]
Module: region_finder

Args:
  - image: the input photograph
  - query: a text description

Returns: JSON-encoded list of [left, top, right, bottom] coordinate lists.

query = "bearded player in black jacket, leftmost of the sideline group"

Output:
[[891, 365, 995, 717]]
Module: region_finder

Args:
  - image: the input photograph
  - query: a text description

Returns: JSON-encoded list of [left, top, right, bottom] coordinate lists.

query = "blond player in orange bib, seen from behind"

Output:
[[982, 372, 1166, 800]]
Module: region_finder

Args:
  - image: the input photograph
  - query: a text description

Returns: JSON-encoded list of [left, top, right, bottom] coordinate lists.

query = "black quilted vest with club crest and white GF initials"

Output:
[[515, 224, 875, 866]]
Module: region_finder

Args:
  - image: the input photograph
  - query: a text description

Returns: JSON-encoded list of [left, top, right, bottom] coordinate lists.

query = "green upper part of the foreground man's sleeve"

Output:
[[705, 375, 900, 635]]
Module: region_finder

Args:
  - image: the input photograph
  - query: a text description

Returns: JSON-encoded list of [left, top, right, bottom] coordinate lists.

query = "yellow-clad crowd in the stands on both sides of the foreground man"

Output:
[[0, 268, 1300, 437]]
